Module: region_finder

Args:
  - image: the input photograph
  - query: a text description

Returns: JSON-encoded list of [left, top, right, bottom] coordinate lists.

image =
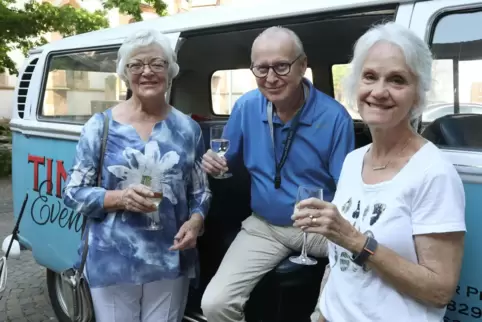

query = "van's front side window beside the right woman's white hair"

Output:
[[428, 11, 482, 122]]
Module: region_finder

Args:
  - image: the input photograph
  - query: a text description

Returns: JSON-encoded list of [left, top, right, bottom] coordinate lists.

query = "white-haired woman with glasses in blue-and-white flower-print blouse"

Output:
[[64, 30, 211, 322]]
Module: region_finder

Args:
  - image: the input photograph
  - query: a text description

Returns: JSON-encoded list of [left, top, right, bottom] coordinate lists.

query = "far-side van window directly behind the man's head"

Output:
[[211, 68, 313, 116]]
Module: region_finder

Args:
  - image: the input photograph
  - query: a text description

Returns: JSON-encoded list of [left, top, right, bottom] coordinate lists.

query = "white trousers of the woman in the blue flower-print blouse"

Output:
[[90, 277, 189, 322]]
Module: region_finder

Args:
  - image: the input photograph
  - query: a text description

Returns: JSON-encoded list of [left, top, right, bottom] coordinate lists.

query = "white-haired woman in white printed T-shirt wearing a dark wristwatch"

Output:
[[293, 23, 466, 322]]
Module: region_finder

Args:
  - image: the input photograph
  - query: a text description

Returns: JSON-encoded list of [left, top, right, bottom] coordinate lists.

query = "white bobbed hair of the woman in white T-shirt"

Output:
[[343, 22, 432, 120]]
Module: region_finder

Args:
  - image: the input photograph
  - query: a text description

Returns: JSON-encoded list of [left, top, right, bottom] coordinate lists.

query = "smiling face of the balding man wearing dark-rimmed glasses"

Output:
[[251, 32, 307, 105]]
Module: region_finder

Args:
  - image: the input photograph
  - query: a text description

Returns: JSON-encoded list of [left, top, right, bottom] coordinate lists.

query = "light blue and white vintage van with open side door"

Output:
[[5, 0, 482, 322]]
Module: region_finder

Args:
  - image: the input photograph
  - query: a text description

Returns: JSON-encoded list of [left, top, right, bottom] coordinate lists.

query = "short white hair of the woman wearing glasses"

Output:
[[117, 29, 179, 86]]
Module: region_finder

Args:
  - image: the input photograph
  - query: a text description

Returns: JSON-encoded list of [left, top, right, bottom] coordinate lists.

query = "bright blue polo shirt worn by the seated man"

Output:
[[224, 79, 355, 226]]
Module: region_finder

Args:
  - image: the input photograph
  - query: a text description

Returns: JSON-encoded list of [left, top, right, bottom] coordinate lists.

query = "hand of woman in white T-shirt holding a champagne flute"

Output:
[[291, 198, 366, 252]]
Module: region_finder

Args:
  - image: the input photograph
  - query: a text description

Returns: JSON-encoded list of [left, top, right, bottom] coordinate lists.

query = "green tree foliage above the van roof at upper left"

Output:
[[0, 0, 167, 74]]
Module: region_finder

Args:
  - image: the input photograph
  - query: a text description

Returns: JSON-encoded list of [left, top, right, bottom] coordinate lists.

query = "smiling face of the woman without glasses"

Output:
[[358, 42, 417, 129]]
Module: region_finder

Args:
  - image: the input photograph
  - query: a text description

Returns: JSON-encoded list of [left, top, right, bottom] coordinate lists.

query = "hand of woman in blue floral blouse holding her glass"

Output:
[[121, 184, 157, 213]]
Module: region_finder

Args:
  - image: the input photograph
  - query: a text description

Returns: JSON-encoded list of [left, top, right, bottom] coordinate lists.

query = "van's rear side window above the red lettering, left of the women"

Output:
[[38, 48, 127, 124]]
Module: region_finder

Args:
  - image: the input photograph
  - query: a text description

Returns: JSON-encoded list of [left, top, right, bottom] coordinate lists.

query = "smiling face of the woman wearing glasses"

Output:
[[126, 45, 169, 99]]
